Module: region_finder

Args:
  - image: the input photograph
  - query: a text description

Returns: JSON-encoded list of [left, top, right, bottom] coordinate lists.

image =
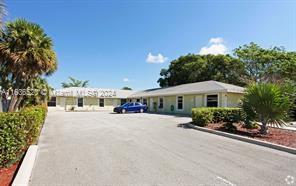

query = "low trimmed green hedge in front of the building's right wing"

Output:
[[191, 107, 243, 127]]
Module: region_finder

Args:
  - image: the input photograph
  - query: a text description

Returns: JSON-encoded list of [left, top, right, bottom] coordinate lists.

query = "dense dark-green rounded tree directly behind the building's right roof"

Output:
[[158, 54, 246, 87]]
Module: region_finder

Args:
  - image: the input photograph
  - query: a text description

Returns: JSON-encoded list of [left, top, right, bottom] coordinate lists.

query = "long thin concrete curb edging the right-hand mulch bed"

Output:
[[186, 123, 296, 155]]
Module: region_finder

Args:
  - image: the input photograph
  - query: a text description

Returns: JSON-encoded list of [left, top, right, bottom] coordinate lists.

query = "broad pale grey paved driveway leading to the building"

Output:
[[30, 112, 296, 186]]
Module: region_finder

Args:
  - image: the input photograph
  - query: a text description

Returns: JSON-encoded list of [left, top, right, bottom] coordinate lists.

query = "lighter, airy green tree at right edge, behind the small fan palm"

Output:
[[234, 42, 296, 82]]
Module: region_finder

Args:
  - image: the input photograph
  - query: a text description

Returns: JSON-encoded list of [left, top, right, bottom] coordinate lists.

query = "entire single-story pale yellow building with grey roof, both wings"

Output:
[[48, 81, 244, 114]]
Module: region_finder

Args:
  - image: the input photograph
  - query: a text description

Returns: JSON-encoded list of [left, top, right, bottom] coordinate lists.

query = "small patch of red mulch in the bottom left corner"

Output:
[[0, 161, 21, 186]]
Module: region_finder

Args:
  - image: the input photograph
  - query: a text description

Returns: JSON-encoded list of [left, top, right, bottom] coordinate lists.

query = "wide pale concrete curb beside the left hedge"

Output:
[[12, 145, 38, 186]]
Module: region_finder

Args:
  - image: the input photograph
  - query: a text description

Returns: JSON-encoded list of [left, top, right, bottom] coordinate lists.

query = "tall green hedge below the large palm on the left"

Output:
[[0, 106, 47, 167]]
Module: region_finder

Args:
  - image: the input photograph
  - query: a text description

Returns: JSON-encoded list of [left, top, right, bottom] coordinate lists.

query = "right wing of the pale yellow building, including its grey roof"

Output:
[[129, 81, 244, 114]]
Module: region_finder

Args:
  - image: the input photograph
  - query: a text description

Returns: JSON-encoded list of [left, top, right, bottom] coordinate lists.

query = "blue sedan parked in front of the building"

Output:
[[113, 102, 148, 113]]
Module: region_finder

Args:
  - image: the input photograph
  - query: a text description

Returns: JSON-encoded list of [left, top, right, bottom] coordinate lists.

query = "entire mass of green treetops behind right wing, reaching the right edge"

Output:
[[158, 43, 296, 87]]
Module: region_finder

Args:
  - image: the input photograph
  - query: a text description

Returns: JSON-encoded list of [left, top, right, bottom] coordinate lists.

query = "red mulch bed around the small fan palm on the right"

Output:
[[206, 123, 296, 148]]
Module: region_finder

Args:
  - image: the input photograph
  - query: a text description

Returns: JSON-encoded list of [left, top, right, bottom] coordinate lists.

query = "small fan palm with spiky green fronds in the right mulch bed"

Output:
[[242, 83, 290, 134]]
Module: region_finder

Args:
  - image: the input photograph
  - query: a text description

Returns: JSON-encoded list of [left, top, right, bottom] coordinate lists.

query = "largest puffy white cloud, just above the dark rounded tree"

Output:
[[199, 37, 228, 55]]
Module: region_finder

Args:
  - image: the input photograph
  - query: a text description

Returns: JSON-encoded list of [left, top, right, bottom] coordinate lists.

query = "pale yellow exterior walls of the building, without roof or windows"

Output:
[[49, 92, 243, 114]]
